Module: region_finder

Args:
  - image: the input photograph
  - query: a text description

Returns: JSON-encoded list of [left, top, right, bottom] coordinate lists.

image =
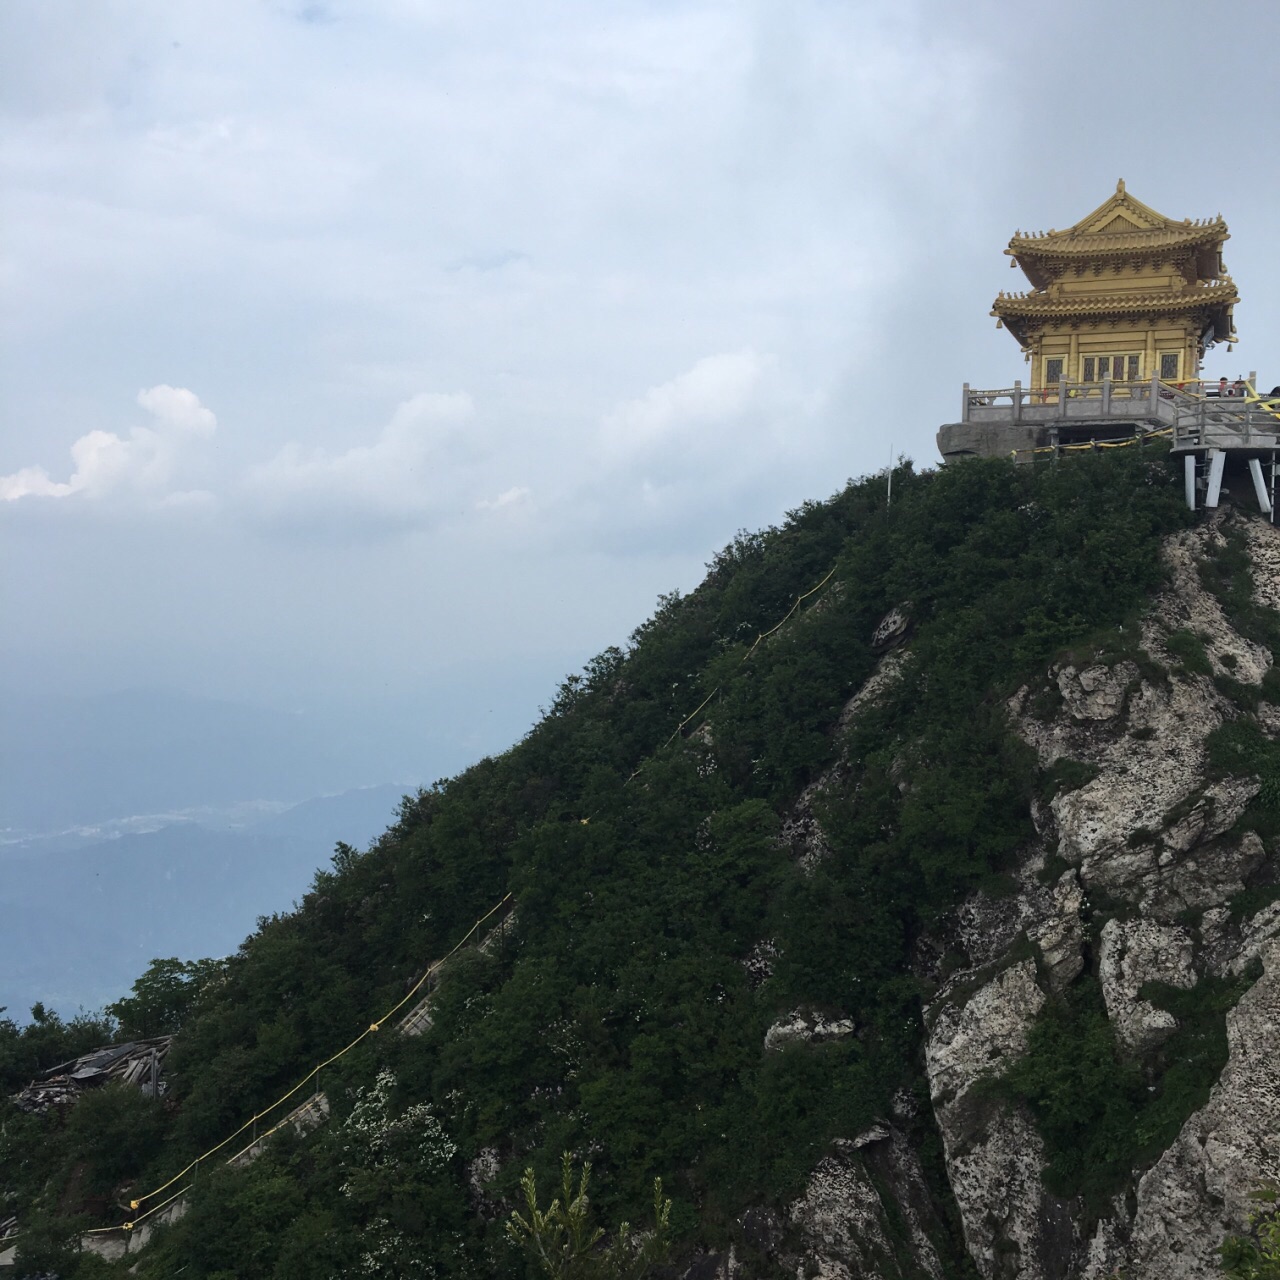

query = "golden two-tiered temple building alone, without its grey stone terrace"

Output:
[[991, 179, 1239, 393]]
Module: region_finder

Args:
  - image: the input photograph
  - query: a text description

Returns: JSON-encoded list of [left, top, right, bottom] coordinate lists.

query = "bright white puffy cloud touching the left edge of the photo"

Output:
[[0, 383, 218, 504]]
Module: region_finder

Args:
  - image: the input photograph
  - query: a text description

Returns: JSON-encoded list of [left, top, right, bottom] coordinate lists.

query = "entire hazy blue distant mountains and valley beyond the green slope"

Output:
[[0, 662, 547, 1020]]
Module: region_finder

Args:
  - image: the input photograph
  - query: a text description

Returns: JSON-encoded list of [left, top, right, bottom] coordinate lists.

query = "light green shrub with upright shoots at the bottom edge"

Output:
[[507, 1151, 671, 1280]]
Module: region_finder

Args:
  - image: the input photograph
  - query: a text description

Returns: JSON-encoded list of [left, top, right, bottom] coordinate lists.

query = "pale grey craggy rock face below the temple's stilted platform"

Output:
[[911, 513, 1280, 1280]]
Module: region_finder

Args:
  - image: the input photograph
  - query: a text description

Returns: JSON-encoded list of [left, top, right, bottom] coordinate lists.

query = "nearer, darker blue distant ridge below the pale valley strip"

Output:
[[0, 785, 407, 1021]]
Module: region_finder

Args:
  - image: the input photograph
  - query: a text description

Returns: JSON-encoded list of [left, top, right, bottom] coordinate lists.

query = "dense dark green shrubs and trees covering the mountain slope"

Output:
[[0, 451, 1199, 1280]]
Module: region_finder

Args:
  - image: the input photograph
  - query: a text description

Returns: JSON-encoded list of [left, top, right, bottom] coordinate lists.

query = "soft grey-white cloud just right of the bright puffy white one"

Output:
[[243, 392, 478, 527]]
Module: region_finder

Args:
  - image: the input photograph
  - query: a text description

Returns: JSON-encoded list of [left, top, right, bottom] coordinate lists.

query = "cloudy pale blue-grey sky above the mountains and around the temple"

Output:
[[0, 0, 1280, 803]]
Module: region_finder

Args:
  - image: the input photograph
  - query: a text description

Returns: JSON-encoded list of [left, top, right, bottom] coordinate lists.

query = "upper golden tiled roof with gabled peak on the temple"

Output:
[[1005, 179, 1230, 289]]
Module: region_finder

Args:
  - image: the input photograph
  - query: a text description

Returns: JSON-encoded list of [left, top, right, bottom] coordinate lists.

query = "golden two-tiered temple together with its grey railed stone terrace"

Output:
[[938, 180, 1280, 522]]
